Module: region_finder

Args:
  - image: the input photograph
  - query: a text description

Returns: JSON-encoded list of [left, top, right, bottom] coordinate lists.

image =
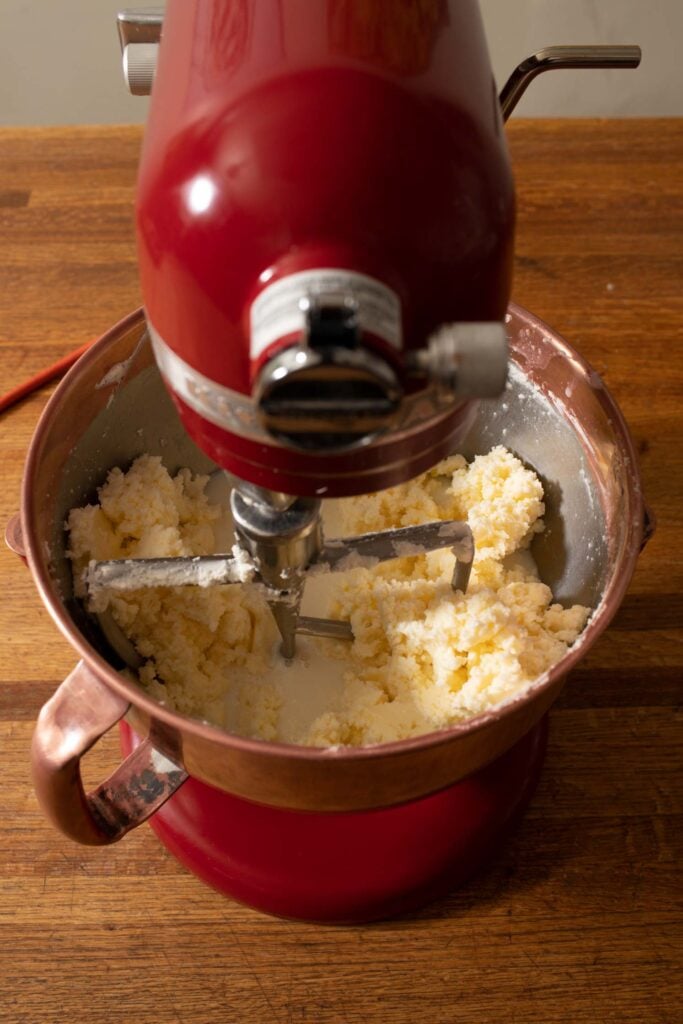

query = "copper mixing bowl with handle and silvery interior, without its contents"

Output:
[[15, 306, 649, 843]]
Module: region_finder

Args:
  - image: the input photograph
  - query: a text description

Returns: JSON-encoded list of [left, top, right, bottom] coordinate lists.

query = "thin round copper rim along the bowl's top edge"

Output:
[[22, 302, 644, 762]]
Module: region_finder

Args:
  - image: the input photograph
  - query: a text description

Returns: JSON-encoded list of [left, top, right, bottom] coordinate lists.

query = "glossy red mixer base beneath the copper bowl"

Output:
[[122, 719, 548, 924]]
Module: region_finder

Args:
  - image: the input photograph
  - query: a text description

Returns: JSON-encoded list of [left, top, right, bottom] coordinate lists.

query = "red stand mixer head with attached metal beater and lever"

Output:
[[107, 0, 639, 657]]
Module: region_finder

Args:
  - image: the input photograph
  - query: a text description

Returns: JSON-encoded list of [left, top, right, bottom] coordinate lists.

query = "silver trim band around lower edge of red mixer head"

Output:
[[147, 319, 471, 447]]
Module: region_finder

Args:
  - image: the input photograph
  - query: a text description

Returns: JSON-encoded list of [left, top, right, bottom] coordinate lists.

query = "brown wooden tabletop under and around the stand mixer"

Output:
[[0, 120, 683, 1024]]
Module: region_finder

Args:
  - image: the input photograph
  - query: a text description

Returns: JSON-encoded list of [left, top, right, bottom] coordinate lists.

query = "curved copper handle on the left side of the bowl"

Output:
[[31, 662, 187, 846]]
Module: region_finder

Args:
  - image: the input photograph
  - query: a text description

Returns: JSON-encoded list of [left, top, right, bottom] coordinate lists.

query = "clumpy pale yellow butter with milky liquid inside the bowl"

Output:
[[67, 446, 589, 746]]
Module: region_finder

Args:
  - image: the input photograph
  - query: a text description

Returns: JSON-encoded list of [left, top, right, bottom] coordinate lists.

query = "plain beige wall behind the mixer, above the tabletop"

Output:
[[0, 0, 683, 124]]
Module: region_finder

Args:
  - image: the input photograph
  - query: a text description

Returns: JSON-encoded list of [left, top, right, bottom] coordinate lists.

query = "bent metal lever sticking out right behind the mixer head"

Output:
[[499, 46, 642, 121]]
